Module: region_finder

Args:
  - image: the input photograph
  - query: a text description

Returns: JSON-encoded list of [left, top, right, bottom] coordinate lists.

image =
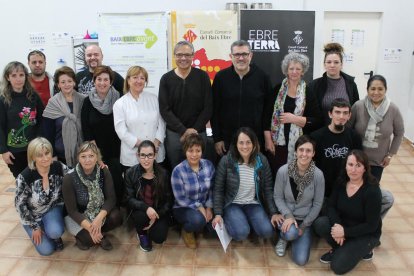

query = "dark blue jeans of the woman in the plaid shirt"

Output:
[[173, 207, 207, 233]]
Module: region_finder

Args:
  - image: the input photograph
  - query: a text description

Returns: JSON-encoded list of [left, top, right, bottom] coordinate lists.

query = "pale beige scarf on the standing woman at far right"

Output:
[[362, 96, 391, 148]]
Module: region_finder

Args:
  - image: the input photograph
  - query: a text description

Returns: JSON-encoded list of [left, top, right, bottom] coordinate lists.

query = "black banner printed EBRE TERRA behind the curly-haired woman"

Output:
[[240, 10, 315, 85]]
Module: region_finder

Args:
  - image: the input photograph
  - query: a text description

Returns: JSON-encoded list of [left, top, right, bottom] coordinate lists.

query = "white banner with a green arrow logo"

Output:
[[98, 12, 168, 95]]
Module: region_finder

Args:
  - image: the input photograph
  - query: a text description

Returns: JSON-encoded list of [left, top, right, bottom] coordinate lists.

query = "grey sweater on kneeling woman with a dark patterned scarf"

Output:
[[273, 164, 325, 229]]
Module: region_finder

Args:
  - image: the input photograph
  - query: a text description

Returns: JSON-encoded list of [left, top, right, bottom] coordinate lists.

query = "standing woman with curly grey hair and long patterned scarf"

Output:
[[264, 52, 321, 178]]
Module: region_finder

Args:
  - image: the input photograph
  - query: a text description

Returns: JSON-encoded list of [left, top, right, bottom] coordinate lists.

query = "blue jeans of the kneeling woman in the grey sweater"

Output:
[[279, 224, 312, 266]]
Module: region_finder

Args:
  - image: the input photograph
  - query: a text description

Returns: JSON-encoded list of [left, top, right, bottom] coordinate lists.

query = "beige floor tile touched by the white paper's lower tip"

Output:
[[195, 247, 230, 266]]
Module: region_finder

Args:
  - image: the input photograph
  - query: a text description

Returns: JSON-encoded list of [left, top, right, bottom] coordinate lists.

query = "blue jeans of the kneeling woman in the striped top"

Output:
[[223, 203, 274, 241]]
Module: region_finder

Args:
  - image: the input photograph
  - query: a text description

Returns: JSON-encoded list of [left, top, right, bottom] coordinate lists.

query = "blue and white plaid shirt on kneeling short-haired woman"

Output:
[[171, 159, 215, 209]]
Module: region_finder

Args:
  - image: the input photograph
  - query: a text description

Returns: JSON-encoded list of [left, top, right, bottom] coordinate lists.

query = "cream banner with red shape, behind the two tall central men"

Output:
[[171, 11, 238, 81]]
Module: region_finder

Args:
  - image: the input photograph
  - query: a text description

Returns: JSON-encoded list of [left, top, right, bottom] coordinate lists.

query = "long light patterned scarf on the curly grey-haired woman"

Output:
[[271, 78, 306, 162]]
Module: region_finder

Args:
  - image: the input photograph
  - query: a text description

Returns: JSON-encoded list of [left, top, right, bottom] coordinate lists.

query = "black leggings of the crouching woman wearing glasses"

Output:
[[132, 210, 169, 243]]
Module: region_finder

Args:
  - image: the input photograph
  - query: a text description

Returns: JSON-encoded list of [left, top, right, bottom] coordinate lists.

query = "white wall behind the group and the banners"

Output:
[[0, 0, 414, 141]]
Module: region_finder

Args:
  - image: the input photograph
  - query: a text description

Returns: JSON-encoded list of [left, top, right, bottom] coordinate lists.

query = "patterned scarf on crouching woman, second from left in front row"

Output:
[[76, 163, 105, 225]]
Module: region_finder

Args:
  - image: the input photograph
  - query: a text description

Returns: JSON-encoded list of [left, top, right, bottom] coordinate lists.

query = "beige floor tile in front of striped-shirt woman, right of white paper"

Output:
[[231, 247, 266, 267]]
